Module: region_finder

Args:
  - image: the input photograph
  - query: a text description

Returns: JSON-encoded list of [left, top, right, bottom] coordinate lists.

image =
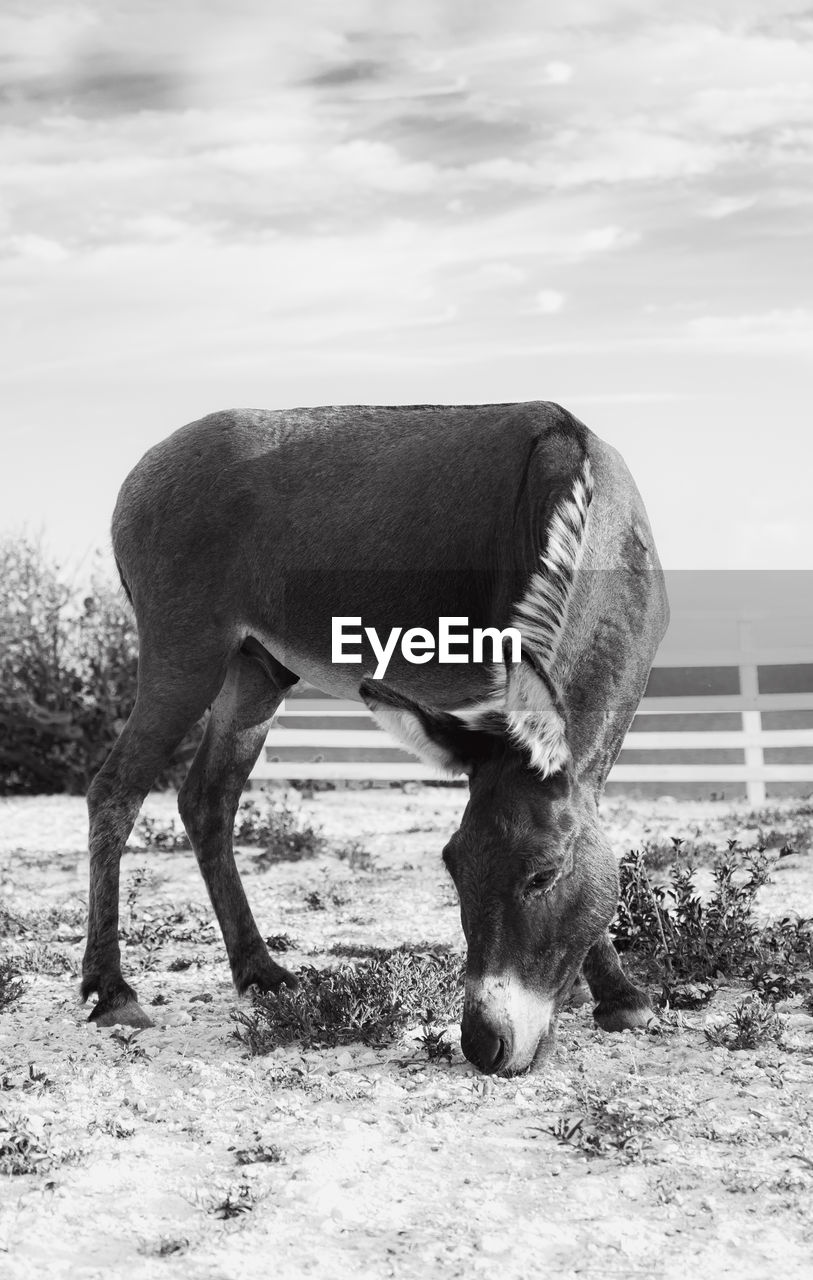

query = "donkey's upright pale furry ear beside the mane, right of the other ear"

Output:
[[503, 652, 570, 778]]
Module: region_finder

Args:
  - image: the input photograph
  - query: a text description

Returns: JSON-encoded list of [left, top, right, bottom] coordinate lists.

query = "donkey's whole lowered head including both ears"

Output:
[[361, 645, 618, 1073]]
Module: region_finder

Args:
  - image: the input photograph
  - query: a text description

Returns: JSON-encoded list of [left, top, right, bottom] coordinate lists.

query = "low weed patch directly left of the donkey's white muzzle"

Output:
[[233, 951, 463, 1053]]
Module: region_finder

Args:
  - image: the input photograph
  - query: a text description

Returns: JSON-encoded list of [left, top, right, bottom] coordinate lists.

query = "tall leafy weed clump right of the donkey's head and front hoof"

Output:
[[612, 841, 813, 1007]]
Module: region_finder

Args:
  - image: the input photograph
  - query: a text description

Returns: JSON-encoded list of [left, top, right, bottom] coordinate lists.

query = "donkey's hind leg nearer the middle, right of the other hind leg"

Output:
[[178, 645, 298, 995]]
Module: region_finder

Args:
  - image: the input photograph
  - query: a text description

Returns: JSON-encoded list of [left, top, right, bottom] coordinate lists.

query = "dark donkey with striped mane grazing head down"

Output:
[[82, 402, 668, 1074]]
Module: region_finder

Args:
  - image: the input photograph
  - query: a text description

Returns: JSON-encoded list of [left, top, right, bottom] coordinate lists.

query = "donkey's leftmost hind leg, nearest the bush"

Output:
[[82, 644, 225, 1027]]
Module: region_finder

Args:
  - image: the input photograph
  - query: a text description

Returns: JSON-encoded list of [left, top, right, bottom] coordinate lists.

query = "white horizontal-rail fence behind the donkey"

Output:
[[250, 608, 813, 804]]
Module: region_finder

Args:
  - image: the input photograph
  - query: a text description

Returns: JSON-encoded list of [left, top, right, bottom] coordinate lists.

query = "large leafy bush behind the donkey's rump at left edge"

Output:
[[0, 535, 201, 795]]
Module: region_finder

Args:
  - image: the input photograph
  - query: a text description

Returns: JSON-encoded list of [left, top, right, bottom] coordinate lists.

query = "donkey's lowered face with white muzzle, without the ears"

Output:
[[443, 744, 618, 1073]]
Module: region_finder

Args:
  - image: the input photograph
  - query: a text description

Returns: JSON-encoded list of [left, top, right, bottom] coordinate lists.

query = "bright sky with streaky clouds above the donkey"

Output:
[[0, 0, 813, 570]]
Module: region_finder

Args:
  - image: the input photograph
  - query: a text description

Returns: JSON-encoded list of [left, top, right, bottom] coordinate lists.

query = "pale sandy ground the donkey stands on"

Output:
[[0, 787, 813, 1280]]
